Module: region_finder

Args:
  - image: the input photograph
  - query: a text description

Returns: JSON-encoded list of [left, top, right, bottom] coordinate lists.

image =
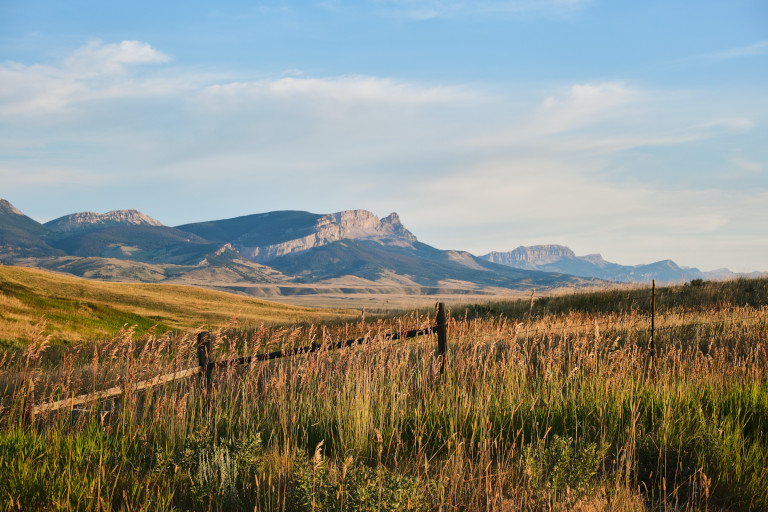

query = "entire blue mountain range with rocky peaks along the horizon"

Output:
[[0, 200, 756, 297]]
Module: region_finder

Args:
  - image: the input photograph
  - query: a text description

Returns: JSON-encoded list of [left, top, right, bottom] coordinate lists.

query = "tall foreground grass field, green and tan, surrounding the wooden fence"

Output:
[[0, 279, 768, 511]]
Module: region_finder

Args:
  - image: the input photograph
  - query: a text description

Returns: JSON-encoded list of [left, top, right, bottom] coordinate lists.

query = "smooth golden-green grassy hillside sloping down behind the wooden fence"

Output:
[[0, 266, 355, 345]]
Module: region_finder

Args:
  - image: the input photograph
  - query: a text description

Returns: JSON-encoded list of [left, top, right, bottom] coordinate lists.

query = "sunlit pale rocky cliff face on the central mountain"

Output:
[[235, 210, 416, 263]]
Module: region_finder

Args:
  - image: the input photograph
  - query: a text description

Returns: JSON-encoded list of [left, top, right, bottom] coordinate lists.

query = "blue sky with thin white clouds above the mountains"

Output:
[[0, 0, 768, 271]]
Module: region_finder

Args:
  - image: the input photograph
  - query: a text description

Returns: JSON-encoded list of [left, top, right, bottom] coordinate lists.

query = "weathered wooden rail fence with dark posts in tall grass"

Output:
[[31, 302, 448, 420]]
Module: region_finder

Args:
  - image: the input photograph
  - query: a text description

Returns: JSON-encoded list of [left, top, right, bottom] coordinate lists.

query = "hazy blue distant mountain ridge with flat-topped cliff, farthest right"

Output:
[[481, 245, 760, 283]]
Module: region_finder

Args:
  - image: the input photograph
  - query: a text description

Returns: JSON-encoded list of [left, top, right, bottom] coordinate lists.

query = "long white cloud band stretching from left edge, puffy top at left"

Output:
[[0, 41, 476, 121]]
